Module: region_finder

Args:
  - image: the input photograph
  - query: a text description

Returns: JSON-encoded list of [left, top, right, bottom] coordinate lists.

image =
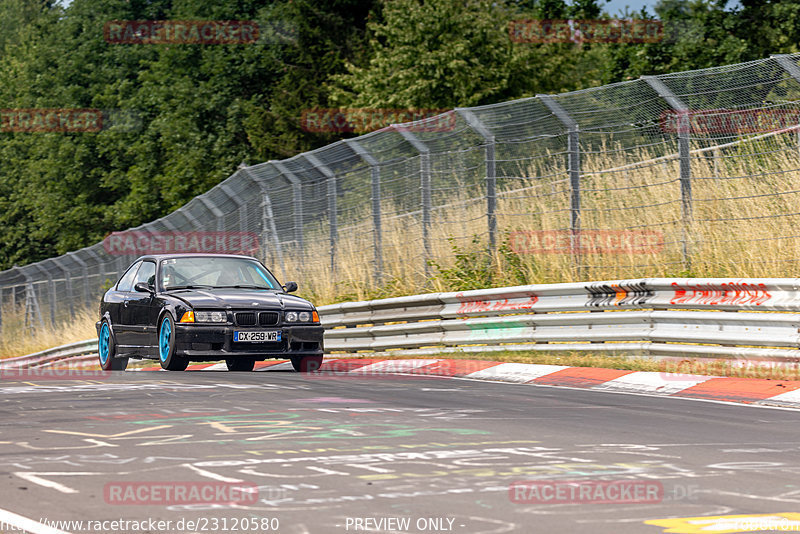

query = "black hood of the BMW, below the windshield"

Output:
[[166, 288, 313, 310]]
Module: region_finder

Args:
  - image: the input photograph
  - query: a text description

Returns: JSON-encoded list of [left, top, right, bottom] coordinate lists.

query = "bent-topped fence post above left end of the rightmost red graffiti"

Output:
[[642, 76, 693, 269]]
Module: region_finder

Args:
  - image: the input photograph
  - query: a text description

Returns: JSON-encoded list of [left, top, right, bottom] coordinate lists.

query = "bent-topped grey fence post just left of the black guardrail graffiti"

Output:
[[536, 95, 583, 280]]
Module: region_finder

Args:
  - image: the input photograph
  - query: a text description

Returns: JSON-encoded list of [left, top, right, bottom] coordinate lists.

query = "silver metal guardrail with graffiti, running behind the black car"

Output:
[[9, 278, 800, 369]]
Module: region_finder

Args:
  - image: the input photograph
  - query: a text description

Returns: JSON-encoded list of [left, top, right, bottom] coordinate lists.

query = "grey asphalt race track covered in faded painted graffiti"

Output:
[[0, 366, 800, 534]]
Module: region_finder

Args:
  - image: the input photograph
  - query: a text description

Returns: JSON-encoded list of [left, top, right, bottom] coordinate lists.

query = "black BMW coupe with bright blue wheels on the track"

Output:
[[97, 254, 323, 371]]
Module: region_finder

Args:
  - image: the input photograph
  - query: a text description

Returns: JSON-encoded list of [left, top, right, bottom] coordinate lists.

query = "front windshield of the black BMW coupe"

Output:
[[160, 256, 281, 291]]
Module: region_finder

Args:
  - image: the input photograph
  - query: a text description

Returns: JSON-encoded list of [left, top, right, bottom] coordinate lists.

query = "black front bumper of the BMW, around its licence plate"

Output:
[[175, 323, 324, 360]]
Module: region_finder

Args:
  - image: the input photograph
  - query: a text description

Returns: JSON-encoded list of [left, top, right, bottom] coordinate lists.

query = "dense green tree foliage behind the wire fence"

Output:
[[0, 0, 800, 268]]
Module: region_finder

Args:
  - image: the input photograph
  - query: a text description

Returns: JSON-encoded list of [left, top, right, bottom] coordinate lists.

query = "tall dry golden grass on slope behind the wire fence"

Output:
[[286, 135, 800, 304]]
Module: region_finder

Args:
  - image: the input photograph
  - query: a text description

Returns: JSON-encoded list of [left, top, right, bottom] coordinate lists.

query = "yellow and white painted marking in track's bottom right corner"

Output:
[[644, 512, 800, 534]]
